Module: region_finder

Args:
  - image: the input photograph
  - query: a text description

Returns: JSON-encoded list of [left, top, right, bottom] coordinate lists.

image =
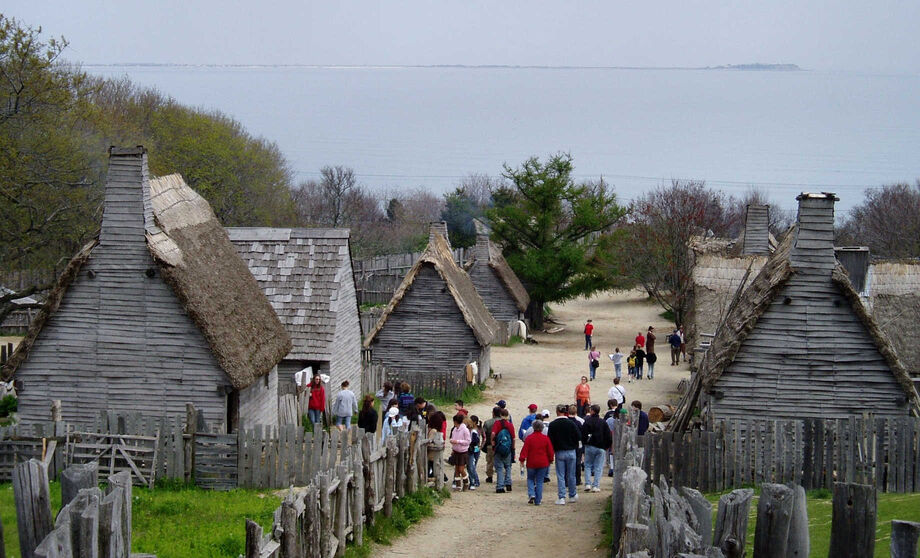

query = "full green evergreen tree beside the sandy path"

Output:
[[487, 154, 626, 329]]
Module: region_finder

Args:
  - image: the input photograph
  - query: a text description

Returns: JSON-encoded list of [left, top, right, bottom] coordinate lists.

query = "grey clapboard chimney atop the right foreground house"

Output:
[[790, 192, 840, 277]]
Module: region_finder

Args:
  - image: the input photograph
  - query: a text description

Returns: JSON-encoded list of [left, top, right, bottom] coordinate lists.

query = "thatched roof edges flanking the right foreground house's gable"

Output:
[[699, 228, 915, 401]]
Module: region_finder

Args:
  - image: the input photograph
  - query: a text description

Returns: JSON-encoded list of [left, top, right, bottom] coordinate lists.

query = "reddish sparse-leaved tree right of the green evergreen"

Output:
[[608, 180, 731, 325]]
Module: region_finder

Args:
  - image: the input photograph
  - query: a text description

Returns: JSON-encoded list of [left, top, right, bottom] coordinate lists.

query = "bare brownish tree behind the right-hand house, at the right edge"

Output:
[[837, 181, 920, 258]]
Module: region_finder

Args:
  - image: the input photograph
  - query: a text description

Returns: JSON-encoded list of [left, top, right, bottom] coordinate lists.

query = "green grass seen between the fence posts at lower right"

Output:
[[706, 489, 920, 558]]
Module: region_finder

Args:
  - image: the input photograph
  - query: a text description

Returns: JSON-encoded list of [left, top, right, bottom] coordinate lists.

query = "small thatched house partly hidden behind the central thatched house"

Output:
[[465, 221, 530, 340]]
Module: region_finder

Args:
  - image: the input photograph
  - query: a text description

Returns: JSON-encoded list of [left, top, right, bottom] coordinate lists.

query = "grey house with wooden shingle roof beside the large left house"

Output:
[[227, 227, 362, 395]]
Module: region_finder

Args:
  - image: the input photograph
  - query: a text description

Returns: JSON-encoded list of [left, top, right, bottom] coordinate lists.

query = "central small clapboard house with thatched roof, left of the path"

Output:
[[364, 225, 499, 382]]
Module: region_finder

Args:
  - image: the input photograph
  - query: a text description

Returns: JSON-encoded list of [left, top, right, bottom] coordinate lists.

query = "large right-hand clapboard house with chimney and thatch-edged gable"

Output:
[[688, 193, 917, 424]]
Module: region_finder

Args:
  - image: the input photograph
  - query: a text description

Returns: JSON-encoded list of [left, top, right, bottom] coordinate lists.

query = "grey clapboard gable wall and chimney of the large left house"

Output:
[[16, 152, 237, 423]]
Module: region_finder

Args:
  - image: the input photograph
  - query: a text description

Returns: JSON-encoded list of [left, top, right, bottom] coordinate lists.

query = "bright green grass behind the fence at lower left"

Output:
[[0, 482, 281, 558]]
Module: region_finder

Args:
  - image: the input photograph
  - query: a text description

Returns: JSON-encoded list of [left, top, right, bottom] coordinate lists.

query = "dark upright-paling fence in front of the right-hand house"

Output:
[[638, 417, 920, 492]]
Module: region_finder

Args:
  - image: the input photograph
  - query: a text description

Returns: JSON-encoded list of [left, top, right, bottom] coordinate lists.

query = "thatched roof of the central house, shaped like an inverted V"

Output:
[[364, 232, 499, 347]]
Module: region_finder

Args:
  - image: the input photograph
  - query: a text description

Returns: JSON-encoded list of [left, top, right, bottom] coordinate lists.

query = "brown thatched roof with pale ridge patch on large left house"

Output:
[[147, 174, 291, 389]]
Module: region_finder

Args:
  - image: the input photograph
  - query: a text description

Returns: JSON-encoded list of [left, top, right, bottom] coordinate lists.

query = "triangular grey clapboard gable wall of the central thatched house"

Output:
[[371, 264, 488, 380]]
